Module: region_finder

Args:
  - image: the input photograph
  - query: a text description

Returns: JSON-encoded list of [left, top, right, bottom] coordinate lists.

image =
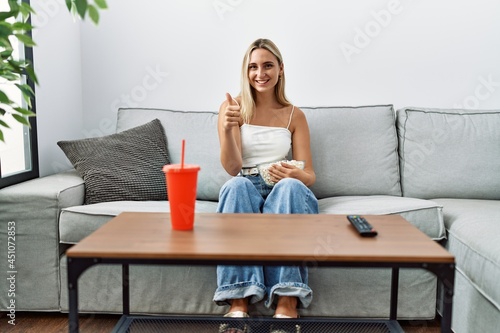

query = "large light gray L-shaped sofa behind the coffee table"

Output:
[[0, 105, 500, 332]]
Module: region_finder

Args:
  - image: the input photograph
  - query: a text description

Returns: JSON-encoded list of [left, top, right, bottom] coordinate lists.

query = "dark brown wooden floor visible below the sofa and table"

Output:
[[0, 312, 440, 333]]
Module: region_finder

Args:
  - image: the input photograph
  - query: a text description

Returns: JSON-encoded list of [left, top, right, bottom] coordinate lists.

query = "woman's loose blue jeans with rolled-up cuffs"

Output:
[[214, 175, 318, 308]]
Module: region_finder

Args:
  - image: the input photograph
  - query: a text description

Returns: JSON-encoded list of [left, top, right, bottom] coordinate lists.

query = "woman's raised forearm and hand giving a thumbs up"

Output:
[[217, 94, 243, 176]]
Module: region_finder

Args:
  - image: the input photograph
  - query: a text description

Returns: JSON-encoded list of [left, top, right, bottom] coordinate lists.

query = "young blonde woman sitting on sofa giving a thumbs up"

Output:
[[214, 39, 318, 332]]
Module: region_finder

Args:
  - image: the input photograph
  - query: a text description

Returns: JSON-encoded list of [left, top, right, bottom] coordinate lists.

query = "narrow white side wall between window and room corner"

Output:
[[31, 0, 83, 176]]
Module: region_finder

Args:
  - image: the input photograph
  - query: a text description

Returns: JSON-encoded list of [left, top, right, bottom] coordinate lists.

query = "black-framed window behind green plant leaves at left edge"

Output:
[[0, 0, 39, 188]]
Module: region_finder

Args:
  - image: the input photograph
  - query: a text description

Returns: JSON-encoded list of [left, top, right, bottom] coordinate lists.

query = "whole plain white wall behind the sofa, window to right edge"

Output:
[[36, 0, 500, 173]]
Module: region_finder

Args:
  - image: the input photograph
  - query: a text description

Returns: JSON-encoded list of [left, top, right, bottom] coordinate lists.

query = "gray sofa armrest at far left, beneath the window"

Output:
[[0, 170, 85, 311]]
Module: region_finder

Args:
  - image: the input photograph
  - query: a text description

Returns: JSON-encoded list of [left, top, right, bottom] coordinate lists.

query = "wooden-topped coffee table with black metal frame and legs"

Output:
[[67, 213, 455, 332]]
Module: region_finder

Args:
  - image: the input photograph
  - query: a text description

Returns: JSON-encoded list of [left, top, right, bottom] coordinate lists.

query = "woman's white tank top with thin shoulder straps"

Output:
[[240, 107, 295, 167]]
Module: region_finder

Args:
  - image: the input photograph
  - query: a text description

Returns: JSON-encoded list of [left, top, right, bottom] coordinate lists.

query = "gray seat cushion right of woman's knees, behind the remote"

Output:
[[319, 195, 445, 240]]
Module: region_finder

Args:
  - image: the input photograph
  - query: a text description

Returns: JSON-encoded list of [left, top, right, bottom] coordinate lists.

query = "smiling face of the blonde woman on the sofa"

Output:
[[248, 49, 283, 92]]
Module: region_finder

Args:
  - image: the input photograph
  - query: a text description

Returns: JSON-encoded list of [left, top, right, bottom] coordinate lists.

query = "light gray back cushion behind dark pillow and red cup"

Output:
[[116, 108, 231, 201]]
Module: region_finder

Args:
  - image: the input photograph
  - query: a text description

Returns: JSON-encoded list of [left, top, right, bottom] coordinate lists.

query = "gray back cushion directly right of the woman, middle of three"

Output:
[[301, 105, 401, 199]]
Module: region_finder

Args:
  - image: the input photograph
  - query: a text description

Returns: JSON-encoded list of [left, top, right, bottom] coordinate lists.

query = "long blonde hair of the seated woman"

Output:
[[240, 38, 291, 123]]
